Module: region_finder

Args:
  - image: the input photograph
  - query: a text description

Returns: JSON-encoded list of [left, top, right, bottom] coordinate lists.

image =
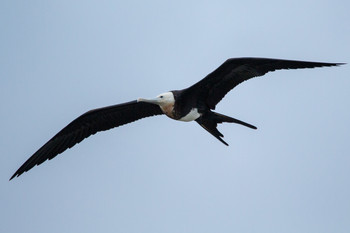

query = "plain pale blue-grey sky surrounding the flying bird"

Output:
[[0, 0, 350, 233]]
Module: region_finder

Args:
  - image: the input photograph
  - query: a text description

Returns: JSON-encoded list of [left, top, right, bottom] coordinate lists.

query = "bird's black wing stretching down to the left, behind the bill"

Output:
[[10, 100, 163, 180]]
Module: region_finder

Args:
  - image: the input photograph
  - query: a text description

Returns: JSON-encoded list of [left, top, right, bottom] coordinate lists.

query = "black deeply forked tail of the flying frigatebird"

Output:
[[196, 112, 257, 146]]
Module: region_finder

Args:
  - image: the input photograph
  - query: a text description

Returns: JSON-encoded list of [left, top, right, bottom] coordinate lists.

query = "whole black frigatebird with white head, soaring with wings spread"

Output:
[[10, 58, 344, 180]]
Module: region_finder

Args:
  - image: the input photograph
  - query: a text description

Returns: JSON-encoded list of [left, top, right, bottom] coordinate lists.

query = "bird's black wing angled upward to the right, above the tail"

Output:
[[187, 58, 341, 109]]
